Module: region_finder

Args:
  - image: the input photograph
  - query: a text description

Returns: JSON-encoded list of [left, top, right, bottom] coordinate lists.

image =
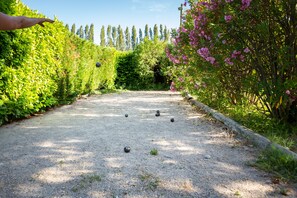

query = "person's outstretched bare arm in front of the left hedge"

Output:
[[0, 12, 54, 30]]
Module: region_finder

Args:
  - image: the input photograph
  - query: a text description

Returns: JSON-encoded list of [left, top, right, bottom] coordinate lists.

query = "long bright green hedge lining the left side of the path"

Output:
[[0, 0, 118, 125]]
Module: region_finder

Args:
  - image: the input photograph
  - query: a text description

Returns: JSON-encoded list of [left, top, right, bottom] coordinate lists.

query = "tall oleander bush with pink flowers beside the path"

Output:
[[167, 0, 297, 121]]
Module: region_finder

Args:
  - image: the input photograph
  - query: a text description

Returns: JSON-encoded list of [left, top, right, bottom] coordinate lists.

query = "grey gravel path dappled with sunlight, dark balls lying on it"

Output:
[[0, 92, 297, 198]]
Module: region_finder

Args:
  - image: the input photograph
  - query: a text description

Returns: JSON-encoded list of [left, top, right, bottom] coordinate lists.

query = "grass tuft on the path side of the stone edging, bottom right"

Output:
[[255, 148, 297, 182]]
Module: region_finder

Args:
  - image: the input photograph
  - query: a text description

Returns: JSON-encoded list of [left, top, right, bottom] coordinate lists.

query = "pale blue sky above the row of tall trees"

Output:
[[22, 0, 184, 43]]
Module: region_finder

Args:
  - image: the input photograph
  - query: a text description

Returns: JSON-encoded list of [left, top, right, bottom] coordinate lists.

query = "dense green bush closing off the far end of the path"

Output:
[[116, 37, 171, 89]]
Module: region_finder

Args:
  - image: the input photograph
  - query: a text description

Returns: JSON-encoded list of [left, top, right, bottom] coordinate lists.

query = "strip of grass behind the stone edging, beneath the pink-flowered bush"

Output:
[[191, 96, 297, 152]]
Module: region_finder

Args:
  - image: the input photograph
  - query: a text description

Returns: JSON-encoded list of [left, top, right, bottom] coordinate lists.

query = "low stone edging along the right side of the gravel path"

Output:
[[184, 93, 297, 160]]
